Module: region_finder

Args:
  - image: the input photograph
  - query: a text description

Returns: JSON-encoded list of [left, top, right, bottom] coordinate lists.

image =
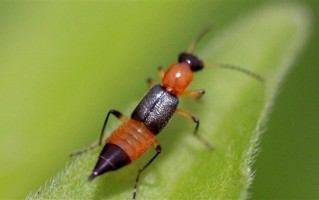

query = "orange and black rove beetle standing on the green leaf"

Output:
[[71, 28, 263, 200]]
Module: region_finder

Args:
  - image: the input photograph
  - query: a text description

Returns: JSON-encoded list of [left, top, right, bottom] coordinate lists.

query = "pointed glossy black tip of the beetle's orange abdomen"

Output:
[[88, 143, 131, 181]]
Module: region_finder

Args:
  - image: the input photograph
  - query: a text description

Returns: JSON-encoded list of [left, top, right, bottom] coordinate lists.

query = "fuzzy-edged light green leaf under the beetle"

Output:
[[28, 4, 309, 199]]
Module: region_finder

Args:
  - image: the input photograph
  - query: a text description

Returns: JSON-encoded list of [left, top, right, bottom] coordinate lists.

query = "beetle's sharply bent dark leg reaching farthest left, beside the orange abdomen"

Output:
[[70, 109, 128, 157]]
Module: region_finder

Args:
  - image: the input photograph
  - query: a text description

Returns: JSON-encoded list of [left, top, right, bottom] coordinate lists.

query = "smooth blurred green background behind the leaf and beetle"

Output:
[[0, 0, 319, 199]]
